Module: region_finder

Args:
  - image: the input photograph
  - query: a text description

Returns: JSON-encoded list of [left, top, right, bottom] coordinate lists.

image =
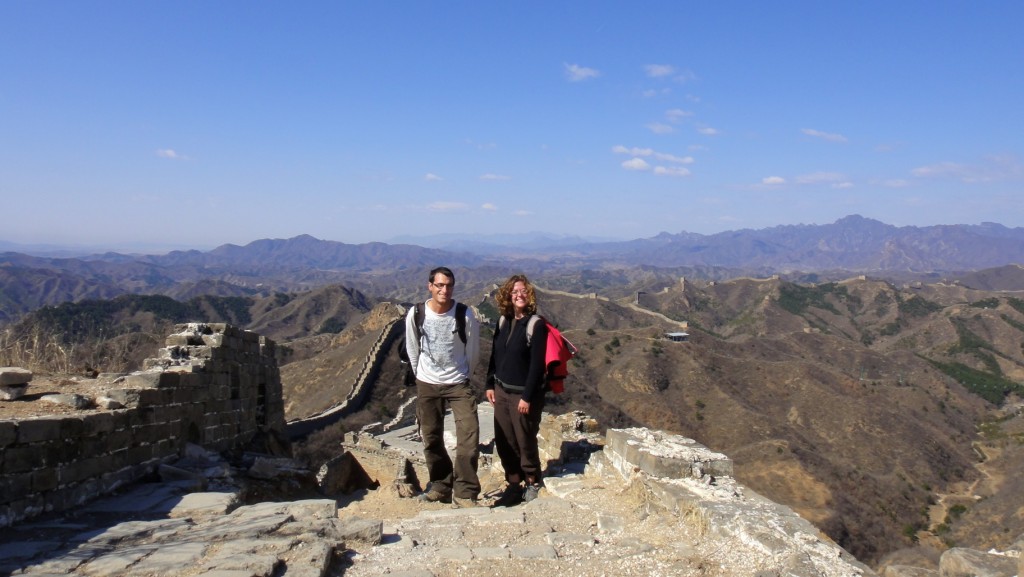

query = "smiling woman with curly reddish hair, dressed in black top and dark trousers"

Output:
[[486, 275, 548, 506]]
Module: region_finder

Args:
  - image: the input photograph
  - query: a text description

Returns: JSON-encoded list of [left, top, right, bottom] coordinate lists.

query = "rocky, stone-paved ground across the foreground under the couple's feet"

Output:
[[0, 444, 757, 577]]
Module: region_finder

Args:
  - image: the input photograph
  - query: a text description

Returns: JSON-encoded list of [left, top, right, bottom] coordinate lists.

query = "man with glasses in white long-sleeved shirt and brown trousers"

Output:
[[406, 266, 480, 506]]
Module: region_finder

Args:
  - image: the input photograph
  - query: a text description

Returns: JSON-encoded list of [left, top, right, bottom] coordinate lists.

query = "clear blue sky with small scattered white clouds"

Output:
[[0, 0, 1024, 248]]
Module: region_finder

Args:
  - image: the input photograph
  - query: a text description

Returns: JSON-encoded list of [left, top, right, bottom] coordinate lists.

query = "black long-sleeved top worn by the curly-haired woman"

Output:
[[487, 317, 548, 403]]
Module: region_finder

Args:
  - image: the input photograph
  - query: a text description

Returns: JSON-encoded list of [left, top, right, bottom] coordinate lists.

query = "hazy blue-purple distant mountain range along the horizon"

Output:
[[0, 215, 1024, 322]]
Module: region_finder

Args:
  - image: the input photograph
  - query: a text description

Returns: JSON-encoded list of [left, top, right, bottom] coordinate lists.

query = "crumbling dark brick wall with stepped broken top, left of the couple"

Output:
[[0, 323, 285, 527]]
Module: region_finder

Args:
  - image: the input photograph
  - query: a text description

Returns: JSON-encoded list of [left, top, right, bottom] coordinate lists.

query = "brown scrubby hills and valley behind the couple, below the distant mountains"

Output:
[[0, 222, 1024, 567]]
